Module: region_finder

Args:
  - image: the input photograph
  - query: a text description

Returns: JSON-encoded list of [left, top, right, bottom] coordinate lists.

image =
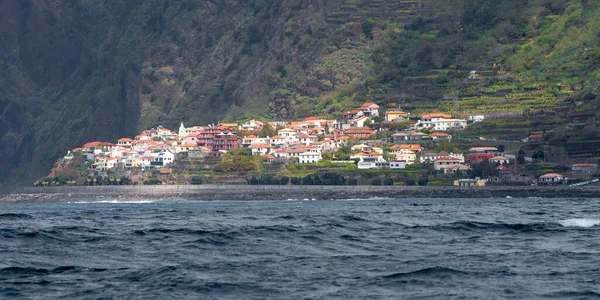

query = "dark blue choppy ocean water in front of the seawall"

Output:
[[0, 198, 600, 299]]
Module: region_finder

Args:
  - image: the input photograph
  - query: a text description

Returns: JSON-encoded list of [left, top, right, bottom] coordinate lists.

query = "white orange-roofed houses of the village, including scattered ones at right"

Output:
[[65, 102, 597, 185]]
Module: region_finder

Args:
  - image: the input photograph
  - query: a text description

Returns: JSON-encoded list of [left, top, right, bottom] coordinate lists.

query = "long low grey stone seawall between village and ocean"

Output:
[[0, 185, 600, 201]]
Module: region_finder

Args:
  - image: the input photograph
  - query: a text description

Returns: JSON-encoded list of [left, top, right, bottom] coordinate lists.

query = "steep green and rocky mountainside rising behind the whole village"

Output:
[[0, 0, 600, 191]]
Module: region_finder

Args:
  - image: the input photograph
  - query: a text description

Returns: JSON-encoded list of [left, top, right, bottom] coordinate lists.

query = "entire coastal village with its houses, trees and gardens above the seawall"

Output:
[[39, 102, 598, 186]]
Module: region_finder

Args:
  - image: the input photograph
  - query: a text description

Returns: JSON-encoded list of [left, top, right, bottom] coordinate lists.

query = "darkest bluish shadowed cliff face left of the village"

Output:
[[0, 0, 140, 190]]
